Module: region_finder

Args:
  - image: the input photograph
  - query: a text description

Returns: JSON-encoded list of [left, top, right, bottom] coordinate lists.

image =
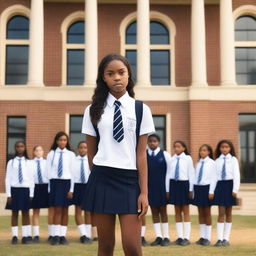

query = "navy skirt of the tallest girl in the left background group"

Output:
[[49, 179, 71, 207]]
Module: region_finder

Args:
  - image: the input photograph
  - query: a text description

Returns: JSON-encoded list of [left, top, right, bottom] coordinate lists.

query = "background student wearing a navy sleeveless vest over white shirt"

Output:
[[147, 134, 171, 246]]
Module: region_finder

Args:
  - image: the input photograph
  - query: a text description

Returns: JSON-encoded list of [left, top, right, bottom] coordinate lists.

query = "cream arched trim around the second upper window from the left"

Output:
[[60, 11, 86, 86]]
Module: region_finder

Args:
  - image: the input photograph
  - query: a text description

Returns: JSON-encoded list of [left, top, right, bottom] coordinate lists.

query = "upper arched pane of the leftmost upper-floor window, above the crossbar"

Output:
[[6, 15, 29, 39]]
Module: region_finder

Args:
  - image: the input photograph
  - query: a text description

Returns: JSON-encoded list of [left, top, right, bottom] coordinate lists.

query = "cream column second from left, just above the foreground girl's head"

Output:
[[84, 0, 98, 86]]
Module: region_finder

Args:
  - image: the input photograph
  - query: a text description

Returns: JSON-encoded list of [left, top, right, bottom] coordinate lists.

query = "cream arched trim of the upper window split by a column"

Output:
[[119, 11, 176, 87]]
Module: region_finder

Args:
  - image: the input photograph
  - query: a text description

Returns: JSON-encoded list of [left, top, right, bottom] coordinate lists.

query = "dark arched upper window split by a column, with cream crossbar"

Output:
[[125, 20, 171, 85]]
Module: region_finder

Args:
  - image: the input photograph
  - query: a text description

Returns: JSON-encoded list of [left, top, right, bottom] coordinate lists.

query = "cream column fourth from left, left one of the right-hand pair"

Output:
[[191, 0, 207, 86]]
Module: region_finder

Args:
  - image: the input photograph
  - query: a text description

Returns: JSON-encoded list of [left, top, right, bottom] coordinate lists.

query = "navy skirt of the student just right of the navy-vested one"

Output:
[[169, 180, 191, 205]]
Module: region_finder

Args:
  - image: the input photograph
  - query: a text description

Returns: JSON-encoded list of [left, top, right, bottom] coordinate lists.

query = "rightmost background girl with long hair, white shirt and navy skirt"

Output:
[[214, 140, 240, 246]]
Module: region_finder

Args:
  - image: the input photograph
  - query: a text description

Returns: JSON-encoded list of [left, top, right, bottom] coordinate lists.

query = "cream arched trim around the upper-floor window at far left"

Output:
[[0, 4, 30, 86]]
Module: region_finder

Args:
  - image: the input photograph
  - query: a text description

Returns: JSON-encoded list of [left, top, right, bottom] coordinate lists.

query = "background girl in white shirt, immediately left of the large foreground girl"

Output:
[[70, 141, 92, 244]]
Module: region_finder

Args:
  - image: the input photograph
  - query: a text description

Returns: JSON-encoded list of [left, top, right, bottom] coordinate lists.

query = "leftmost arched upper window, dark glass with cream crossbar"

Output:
[[5, 15, 29, 85]]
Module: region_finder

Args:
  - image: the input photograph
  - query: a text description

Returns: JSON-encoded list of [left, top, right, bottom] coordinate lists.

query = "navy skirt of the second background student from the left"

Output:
[[32, 184, 49, 209]]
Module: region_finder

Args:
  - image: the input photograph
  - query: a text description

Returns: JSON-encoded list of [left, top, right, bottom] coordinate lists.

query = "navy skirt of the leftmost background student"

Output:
[[5, 187, 31, 211]]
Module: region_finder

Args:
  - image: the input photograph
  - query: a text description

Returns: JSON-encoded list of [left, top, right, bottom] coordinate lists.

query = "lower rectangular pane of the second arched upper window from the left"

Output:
[[67, 50, 84, 85]]
